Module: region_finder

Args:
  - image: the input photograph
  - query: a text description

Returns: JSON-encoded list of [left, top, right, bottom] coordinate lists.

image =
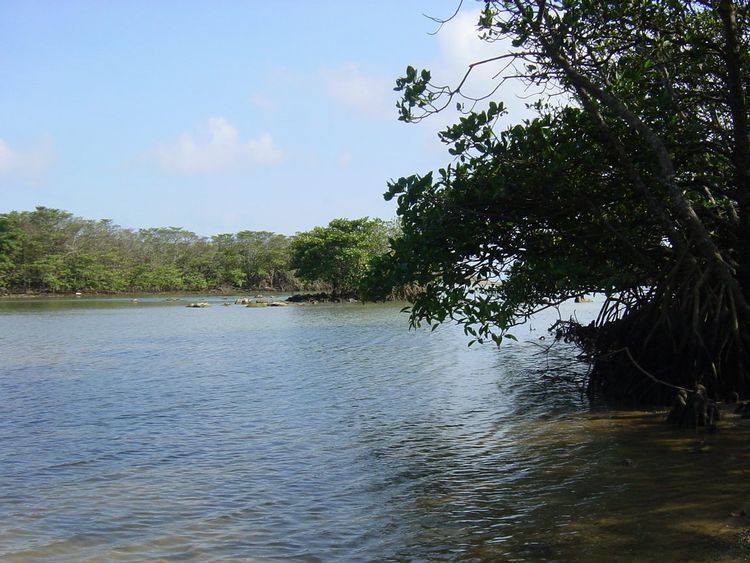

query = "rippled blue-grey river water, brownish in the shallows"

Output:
[[0, 297, 750, 561]]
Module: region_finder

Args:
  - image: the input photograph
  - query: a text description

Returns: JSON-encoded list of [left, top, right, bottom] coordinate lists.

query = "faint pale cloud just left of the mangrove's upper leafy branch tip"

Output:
[[321, 63, 396, 119]]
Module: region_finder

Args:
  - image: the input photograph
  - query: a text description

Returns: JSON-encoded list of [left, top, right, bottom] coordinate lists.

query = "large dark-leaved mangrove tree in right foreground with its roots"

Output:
[[372, 0, 750, 404]]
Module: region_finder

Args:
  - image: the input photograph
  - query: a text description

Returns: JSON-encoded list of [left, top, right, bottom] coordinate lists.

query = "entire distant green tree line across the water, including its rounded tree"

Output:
[[0, 206, 395, 294]]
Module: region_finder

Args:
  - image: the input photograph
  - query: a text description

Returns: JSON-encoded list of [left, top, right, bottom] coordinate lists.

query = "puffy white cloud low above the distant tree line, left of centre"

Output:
[[156, 117, 283, 174]]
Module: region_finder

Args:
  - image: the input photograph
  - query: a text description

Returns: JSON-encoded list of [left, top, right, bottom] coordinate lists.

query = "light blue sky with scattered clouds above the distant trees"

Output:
[[0, 0, 519, 235]]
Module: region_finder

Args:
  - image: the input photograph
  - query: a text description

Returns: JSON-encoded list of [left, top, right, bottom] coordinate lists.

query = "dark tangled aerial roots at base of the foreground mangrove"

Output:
[[554, 262, 750, 408]]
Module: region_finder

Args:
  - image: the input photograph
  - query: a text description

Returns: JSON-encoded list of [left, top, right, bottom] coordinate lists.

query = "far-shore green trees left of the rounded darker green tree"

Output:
[[0, 207, 301, 293]]
